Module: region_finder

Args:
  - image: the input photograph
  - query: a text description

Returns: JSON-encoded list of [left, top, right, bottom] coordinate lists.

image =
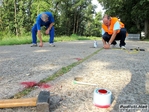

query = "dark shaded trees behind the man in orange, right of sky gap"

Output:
[[98, 0, 149, 38]]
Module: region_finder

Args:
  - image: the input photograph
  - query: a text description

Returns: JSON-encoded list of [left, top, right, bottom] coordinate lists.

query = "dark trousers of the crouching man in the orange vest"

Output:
[[102, 28, 127, 47]]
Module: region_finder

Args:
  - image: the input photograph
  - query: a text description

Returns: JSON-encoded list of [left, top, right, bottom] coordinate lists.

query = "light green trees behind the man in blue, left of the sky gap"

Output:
[[0, 0, 101, 39]]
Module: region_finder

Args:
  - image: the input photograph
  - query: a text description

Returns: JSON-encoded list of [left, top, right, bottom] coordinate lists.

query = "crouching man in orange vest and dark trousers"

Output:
[[102, 15, 127, 49]]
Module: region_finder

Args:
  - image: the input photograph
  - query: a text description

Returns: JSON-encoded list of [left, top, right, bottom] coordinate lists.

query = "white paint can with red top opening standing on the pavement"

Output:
[[93, 88, 112, 108]]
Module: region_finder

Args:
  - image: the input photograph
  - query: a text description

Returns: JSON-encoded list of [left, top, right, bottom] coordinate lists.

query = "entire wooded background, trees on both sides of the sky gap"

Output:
[[0, 0, 149, 39]]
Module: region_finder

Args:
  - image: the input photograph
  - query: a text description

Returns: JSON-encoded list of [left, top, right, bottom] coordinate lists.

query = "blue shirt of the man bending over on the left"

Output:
[[36, 12, 54, 30]]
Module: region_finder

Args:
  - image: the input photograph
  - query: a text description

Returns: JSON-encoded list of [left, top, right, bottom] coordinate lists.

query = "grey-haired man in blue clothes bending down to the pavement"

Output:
[[31, 12, 55, 47]]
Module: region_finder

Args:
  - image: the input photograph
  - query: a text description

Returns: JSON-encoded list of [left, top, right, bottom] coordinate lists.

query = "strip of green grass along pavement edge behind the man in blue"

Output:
[[0, 35, 101, 46]]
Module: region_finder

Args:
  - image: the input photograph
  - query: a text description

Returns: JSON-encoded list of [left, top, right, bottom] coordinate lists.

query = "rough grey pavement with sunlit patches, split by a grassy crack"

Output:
[[0, 40, 149, 112]]
